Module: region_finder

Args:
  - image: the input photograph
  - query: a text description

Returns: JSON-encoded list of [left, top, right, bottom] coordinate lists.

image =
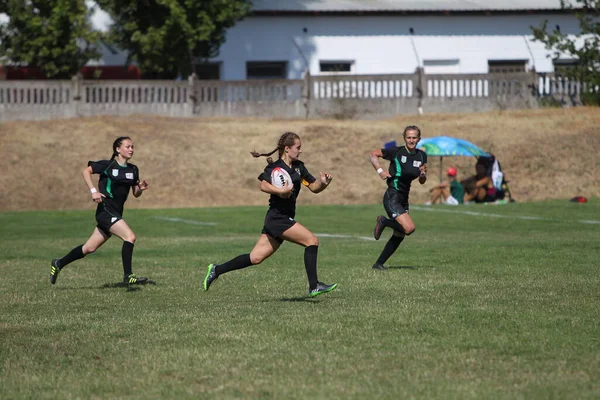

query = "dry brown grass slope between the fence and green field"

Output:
[[0, 108, 600, 211]]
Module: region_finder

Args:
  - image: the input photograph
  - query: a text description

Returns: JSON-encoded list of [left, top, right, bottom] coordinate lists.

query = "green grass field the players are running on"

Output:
[[0, 199, 600, 399]]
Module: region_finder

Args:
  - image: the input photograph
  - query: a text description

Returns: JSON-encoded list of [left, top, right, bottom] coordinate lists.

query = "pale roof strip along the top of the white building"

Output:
[[252, 0, 561, 14]]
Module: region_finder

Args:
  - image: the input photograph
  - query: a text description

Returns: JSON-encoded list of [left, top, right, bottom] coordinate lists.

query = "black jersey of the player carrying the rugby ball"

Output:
[[258, 158, 316, 218]]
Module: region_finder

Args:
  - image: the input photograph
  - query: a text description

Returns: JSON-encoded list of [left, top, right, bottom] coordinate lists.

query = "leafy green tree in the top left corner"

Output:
[[0, 0, 100, 79]]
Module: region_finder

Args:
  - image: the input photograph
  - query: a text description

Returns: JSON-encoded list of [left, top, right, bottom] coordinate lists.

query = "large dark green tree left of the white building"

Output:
[[97, 0, 250, 79]]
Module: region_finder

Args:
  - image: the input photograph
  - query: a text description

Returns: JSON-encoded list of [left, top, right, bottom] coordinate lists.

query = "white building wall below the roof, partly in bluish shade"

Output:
[[213, 14, 579, 80]]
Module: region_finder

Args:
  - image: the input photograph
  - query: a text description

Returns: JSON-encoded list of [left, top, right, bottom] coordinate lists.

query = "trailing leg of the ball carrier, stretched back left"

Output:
[[203, 233, 281, 290]]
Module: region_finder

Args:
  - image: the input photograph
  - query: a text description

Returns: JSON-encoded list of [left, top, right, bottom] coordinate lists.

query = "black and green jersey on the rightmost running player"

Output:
[[381, 146, 427, 198]]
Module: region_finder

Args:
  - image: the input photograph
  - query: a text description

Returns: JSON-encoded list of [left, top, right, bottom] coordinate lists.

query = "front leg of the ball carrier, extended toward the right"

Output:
[[281, 223, 337, 296]]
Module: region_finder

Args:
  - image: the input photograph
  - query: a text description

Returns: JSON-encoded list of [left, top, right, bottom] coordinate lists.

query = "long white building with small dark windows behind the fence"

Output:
[[203, 0, 579, 80]]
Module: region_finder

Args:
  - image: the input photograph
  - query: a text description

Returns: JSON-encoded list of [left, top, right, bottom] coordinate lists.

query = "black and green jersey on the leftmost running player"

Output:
[[88, 160, 140, 214]]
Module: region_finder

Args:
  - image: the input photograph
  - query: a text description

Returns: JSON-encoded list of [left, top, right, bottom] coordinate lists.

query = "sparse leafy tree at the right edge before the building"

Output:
[[531, 0, 600, 105]]
